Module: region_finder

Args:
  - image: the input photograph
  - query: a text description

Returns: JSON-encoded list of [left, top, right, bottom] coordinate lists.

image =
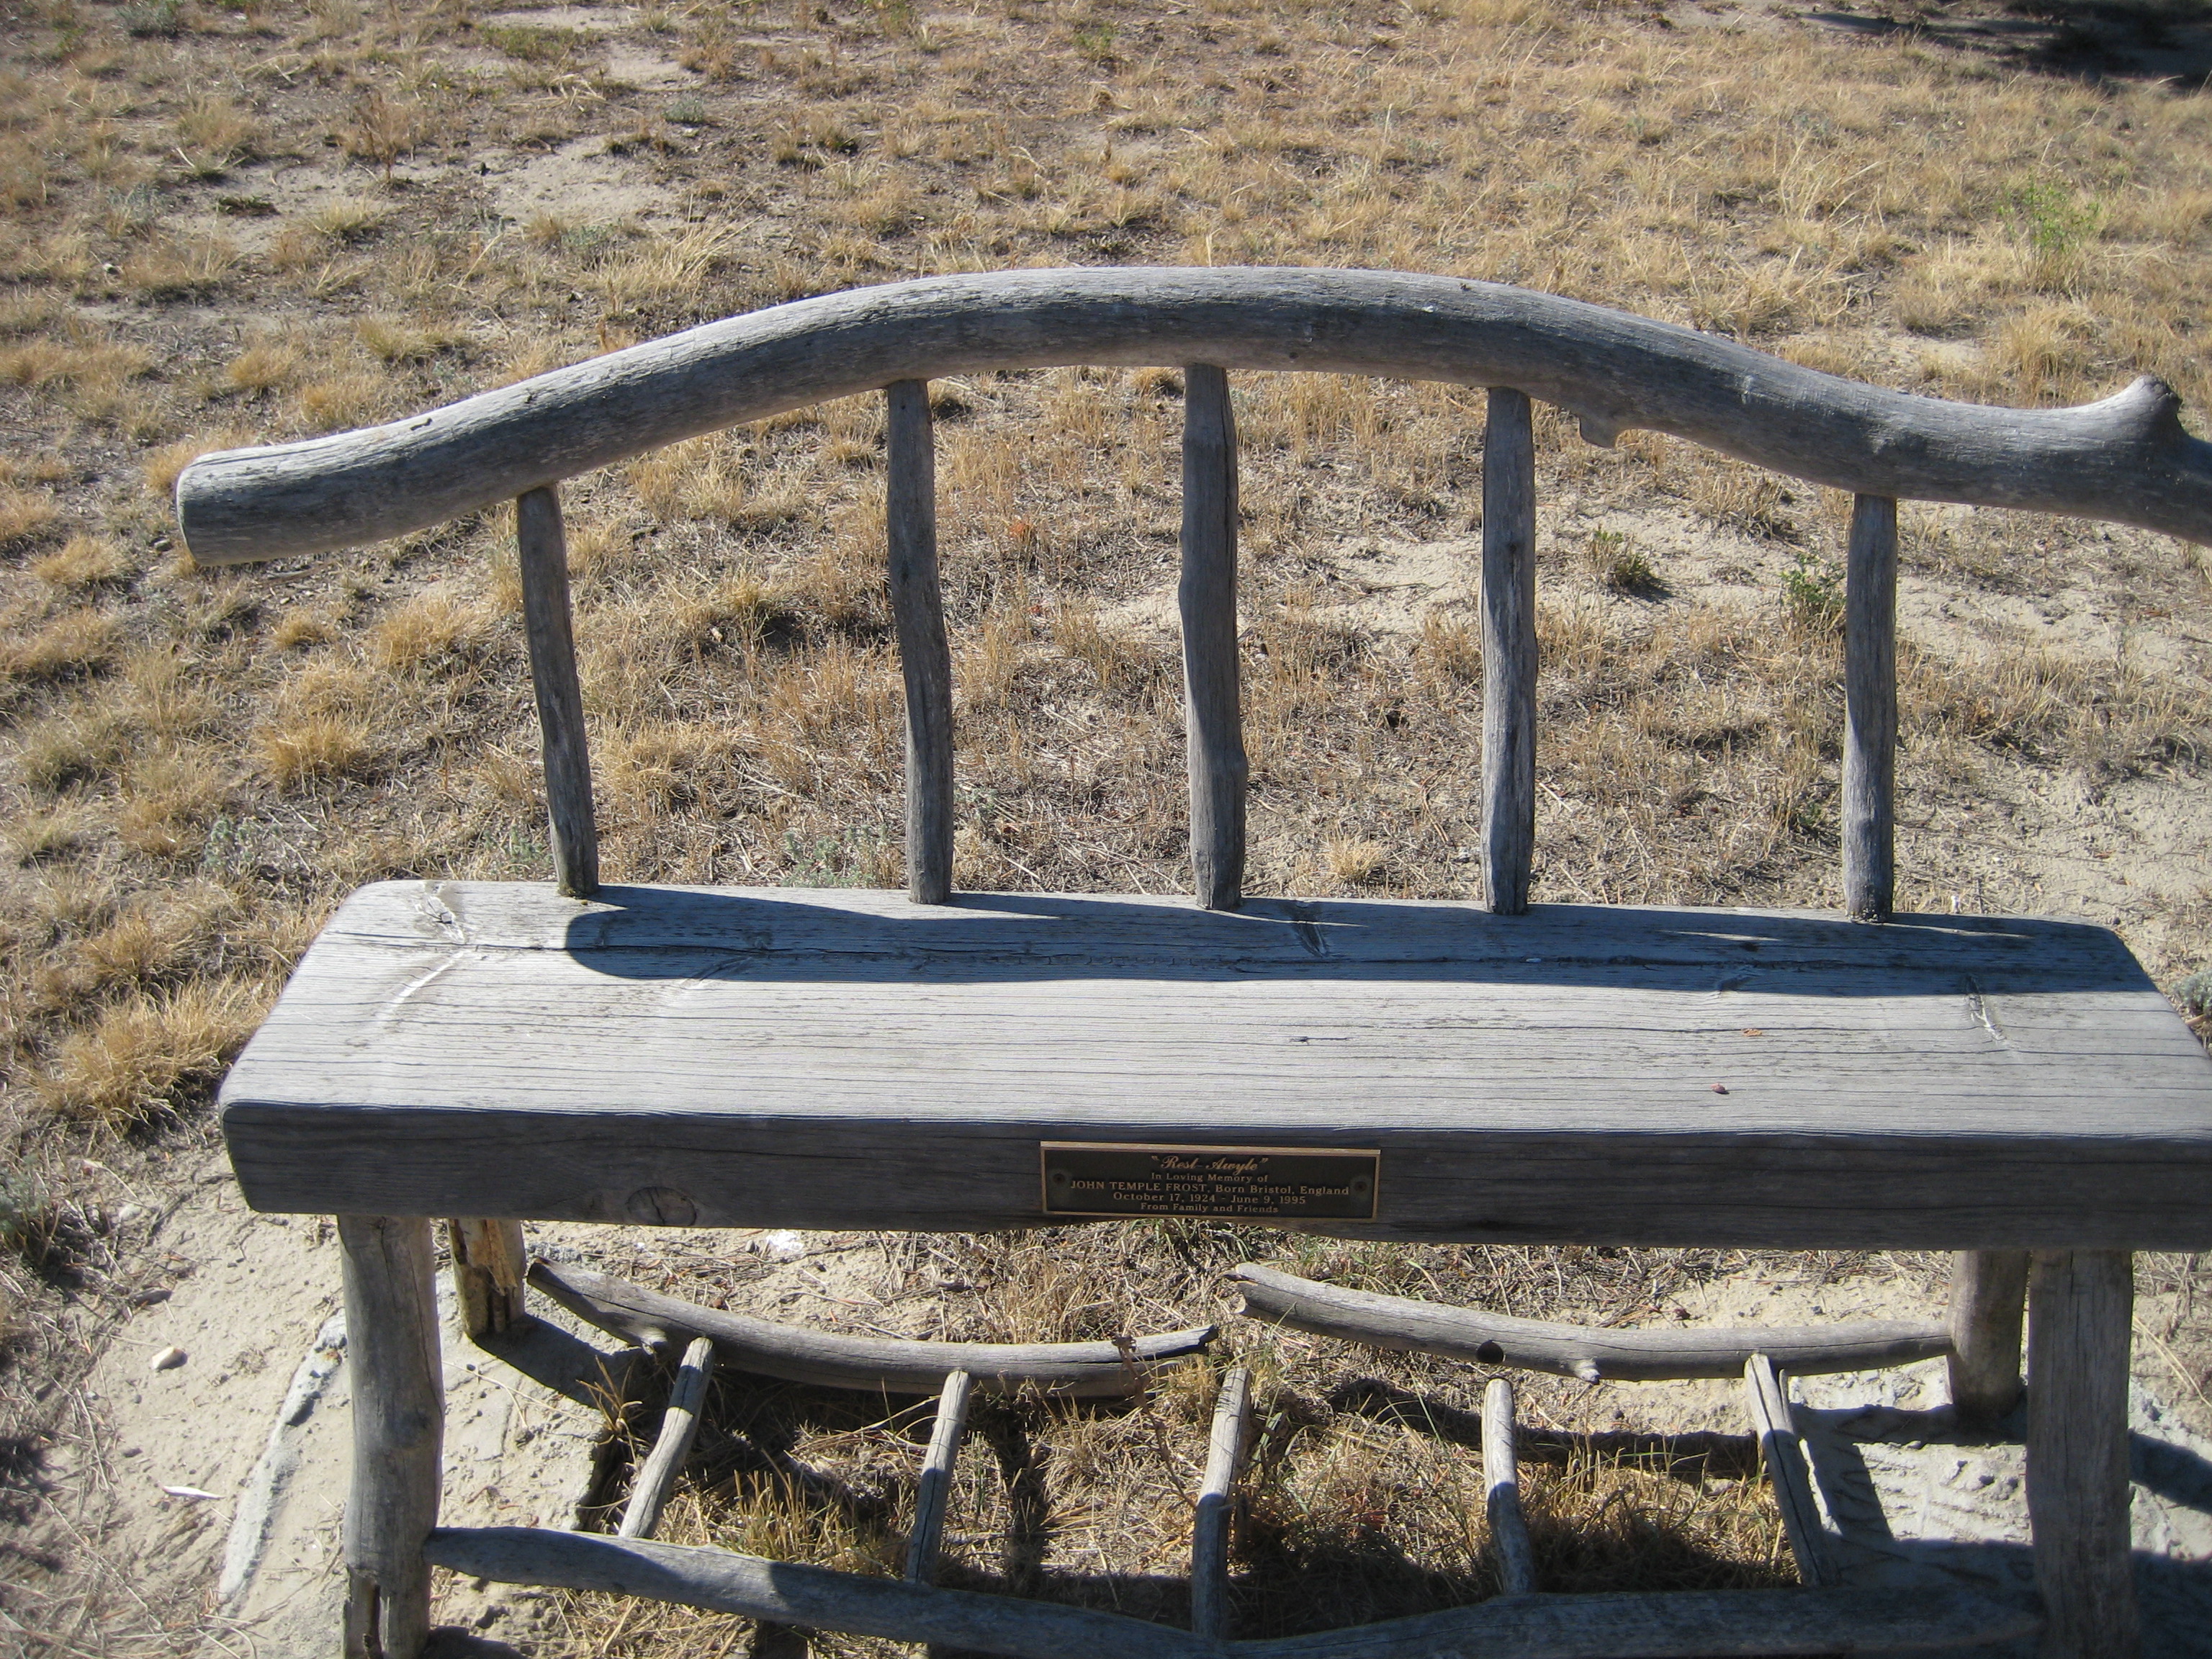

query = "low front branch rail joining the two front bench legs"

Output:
[[427, 1527, 2037, 1659]]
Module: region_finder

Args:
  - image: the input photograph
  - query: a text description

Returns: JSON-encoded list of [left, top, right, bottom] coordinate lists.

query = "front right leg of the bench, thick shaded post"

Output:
[[2028, 1250, 2139, 1659]]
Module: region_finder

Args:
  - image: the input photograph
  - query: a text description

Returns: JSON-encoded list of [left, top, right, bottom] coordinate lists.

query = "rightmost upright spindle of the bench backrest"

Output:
[[1843, 495, 1898, 922]]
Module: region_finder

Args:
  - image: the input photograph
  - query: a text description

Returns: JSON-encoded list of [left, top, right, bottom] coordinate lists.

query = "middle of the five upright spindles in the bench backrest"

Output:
[[1174, 363, 1248, 909]]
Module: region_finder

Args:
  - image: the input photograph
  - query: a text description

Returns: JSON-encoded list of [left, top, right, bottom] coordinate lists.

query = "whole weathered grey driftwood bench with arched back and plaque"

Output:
[[177, 270, 2212, 1659]]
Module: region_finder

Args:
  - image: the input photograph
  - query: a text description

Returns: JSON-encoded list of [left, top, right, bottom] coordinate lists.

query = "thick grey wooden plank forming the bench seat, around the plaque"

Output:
[[221, 883, 2212, 1250]]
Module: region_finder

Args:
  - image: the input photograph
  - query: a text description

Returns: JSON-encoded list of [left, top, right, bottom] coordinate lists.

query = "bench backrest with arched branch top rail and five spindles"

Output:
[[177, 268, 2212, 920]]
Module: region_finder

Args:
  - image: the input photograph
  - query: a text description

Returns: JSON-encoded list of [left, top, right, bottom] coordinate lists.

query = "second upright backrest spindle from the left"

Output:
[[883, 380, 953, 904]]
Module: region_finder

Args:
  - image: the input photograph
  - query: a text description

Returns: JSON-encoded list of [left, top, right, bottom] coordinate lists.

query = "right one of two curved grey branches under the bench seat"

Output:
[[1230, 1263, 1951, 1382]]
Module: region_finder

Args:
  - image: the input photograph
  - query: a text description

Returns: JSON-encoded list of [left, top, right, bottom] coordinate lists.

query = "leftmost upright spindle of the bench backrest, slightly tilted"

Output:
[[516, 485, 600, 898]]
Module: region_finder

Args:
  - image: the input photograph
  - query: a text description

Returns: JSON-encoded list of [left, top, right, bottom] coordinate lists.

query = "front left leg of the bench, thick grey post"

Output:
[[338, 1215, 444, 1659]]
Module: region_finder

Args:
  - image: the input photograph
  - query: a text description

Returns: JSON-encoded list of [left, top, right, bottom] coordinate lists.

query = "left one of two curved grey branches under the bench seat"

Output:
[[531, 1261, 1215, 1395]]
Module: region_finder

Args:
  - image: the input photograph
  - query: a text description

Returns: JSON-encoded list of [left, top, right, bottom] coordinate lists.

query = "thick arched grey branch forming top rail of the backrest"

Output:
[[177, 268, 2212, 564]]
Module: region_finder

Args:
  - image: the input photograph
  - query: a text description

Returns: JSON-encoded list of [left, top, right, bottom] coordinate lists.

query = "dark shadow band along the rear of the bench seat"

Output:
[[535, 887, 2154, 997]]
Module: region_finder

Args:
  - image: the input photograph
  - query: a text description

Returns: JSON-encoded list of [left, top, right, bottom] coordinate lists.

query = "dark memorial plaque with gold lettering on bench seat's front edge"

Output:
[[1042, 1141, 1382, 1221]]
